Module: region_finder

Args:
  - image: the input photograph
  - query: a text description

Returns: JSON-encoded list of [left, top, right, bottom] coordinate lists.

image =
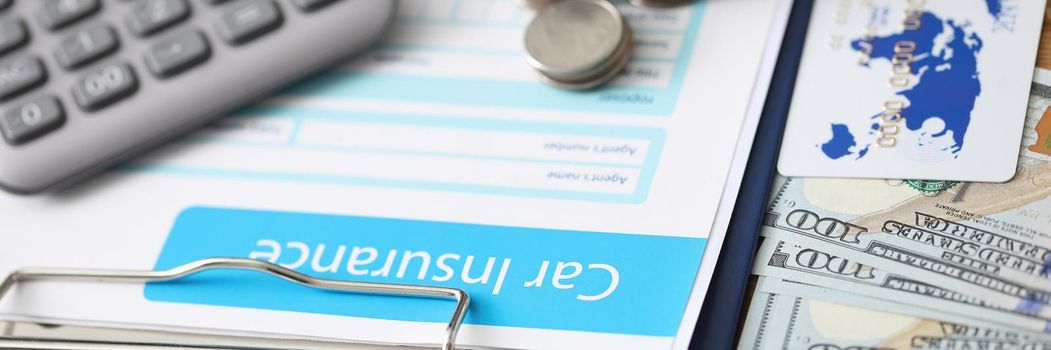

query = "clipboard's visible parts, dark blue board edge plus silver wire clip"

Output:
[[0, 0, 813, 350]]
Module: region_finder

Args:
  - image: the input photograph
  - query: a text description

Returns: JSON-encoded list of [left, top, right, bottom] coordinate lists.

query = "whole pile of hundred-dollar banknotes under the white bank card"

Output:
[[739, 69, 1051, 350]]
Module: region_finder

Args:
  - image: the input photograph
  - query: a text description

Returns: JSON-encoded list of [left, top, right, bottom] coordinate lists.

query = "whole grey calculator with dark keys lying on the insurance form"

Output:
[[0, 0, 397, 193]]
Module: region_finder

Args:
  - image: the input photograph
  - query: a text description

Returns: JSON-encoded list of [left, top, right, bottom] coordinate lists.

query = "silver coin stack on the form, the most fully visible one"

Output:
[[526, 0, 634, 89]]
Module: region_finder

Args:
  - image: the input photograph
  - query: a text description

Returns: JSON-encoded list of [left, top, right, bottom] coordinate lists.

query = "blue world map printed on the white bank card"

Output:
[[819, 0, 1003, 160]]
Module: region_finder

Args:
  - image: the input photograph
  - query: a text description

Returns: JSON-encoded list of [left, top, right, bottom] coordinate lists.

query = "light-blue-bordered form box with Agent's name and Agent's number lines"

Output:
[[126, 108, 664, 203]]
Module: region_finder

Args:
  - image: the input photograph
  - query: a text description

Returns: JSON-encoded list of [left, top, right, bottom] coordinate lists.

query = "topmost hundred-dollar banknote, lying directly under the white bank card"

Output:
[[762, 71, 1051, 313]]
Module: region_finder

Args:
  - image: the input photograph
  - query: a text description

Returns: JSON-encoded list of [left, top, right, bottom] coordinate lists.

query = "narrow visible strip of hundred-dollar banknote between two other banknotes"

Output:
[[754, 240, 1051, 332]]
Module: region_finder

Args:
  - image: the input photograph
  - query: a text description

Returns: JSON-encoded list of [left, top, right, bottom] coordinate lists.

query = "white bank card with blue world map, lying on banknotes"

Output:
[[778, 0, 1047, 182]]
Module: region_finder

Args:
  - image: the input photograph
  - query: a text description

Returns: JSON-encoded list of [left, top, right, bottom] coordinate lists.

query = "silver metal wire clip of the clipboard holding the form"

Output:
[[0, 258, 470, 350]]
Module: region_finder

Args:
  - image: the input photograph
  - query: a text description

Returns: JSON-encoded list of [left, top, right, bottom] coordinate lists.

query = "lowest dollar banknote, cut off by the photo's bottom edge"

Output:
[[738, 277, 1051, 350]]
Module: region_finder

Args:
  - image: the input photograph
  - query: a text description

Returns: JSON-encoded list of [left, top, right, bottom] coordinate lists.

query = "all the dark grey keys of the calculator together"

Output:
[[0, 0, 315, 145]]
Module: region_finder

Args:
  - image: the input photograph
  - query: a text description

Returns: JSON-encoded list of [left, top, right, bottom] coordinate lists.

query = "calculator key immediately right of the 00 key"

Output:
[[146, 32, 210, 77]]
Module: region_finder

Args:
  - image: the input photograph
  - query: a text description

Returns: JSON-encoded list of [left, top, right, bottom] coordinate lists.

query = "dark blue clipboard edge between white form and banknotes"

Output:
[[689, 0, 813, 350]]
